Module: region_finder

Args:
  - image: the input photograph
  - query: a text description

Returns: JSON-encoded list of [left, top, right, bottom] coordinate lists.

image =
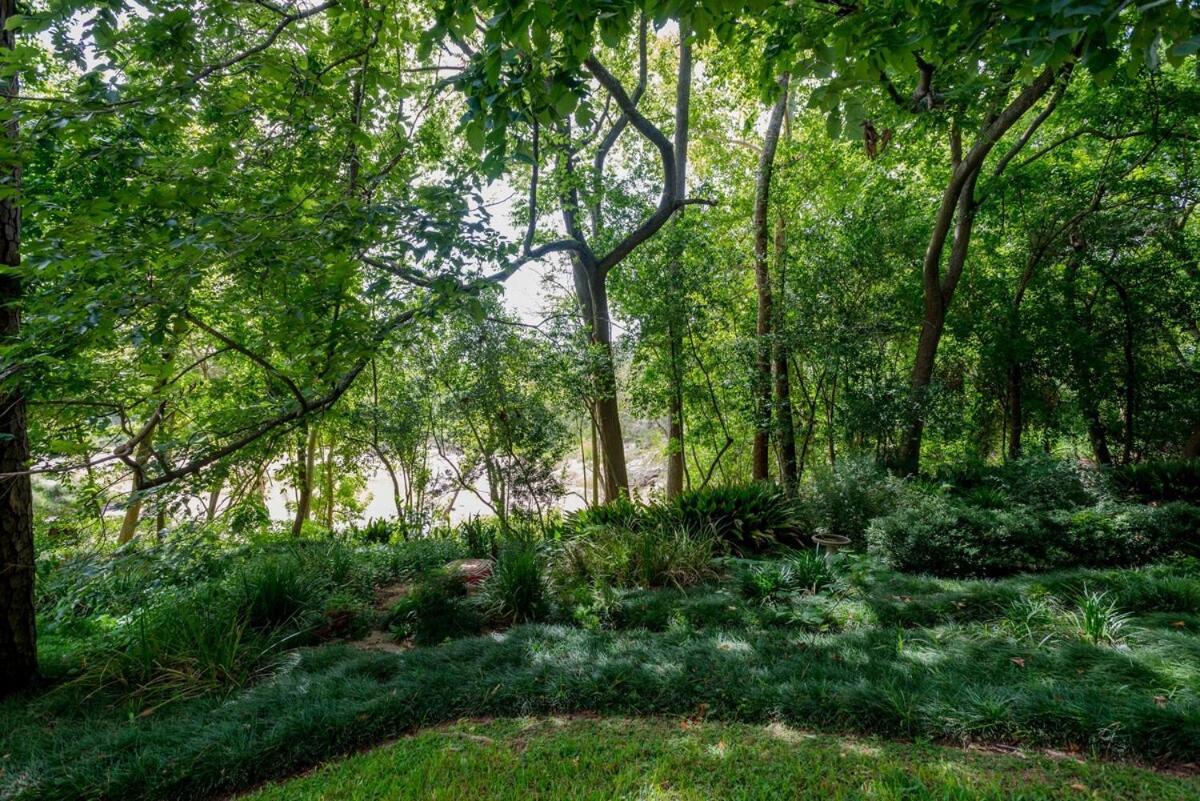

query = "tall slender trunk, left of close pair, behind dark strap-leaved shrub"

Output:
[[751, 76, 787, 481]]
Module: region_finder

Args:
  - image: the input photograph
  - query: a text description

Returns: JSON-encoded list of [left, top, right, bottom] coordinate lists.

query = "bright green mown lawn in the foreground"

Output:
[[246, 718, 1200, 801]]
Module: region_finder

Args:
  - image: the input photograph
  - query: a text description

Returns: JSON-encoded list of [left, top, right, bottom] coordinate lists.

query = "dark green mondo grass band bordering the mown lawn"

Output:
[[0, 568, 1200, 801]]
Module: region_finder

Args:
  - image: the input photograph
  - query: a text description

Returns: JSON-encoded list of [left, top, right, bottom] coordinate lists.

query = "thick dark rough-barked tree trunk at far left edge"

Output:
[[0, 0, 37, 695]]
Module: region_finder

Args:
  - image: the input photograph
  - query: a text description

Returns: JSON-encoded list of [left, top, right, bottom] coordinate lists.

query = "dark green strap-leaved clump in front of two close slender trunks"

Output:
[[670, 482, 800, 553]]
